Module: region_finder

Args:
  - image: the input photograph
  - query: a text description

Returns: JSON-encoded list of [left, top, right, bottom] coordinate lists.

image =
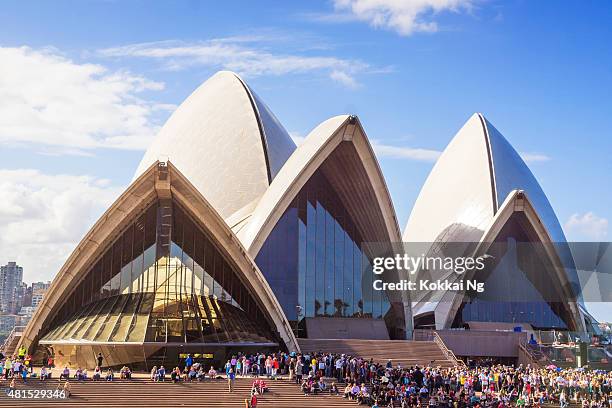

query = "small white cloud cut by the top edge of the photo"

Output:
[[328, 0, 474, 36]]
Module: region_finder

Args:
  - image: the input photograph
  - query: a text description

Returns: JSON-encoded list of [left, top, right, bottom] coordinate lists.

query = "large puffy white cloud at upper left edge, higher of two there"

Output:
[[0, 47, 168, 153]]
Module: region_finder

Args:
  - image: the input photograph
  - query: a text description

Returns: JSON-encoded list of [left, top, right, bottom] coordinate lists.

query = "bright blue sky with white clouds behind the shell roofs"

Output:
[[0, 0, 612, 320]]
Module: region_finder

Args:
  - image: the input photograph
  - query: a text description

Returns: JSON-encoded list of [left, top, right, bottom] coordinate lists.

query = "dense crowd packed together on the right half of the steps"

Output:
[[289, 353, 612, 408]]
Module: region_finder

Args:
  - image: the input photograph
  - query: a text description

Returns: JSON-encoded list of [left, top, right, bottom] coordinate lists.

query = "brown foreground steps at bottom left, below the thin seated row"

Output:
[[0, 378, 355, 408]]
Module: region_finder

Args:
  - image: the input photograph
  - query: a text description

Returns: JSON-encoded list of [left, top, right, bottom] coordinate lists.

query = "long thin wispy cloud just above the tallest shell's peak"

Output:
[[98, 37, 372, 88]]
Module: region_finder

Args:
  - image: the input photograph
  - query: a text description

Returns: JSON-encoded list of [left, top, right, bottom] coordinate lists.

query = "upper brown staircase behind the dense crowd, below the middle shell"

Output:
[[298, 339, 457, 367]]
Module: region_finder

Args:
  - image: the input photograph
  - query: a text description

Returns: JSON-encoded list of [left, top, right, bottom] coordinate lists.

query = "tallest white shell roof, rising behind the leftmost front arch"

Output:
[[134, 71, 295, 222]]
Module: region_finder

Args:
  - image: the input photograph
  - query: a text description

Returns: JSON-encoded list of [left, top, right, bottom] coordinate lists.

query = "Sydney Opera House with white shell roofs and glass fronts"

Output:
[[15, 72, 589, 367]]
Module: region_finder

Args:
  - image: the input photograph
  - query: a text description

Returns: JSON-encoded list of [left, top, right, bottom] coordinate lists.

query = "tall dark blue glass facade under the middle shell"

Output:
[[255, 170, 389, 321]]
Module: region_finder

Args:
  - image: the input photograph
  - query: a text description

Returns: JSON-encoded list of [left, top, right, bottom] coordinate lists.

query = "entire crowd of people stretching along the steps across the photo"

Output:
[[0, 342, 612, 408]]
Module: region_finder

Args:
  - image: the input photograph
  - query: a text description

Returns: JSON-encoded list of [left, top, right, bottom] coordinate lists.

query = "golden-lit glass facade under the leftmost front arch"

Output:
[[41, 200, 278, 344]]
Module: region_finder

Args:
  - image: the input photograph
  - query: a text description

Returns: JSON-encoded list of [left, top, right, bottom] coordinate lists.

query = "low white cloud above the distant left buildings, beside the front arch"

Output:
[[0, 169, 121, 281]]
